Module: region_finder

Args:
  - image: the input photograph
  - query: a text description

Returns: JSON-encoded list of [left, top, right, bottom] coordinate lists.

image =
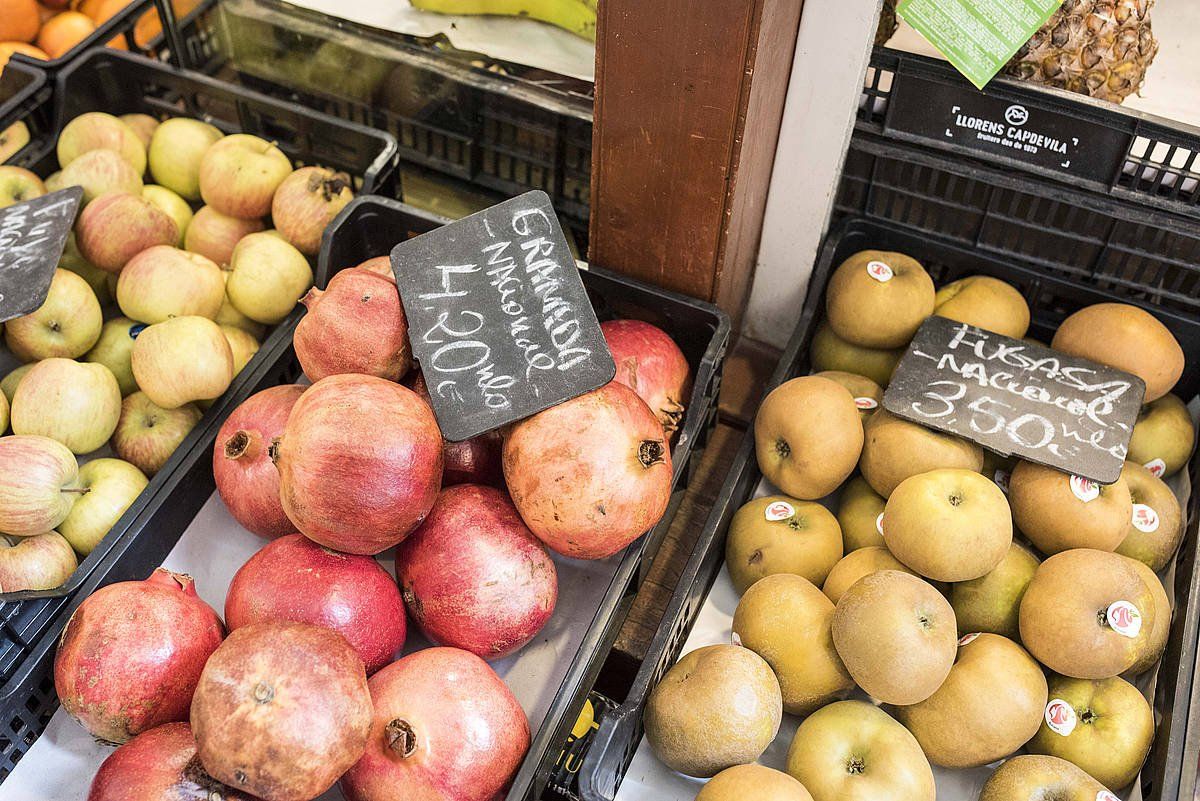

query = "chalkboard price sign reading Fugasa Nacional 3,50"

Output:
[[883, 317, 1146, 484]]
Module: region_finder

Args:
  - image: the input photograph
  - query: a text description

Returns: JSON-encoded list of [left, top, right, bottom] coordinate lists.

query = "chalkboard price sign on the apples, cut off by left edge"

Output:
[[0, 186, 83, 323]]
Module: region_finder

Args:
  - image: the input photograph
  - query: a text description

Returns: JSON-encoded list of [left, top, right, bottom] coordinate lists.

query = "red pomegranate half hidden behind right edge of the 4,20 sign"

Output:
[[600, 320, 691, 438]]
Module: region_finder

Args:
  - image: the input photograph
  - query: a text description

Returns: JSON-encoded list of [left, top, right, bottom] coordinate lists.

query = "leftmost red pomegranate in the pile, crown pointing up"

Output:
[[54, 567, 224, 742]]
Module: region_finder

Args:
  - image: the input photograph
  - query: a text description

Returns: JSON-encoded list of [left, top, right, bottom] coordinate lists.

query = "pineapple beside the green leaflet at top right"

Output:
[[1004, 0, 1158, 103]]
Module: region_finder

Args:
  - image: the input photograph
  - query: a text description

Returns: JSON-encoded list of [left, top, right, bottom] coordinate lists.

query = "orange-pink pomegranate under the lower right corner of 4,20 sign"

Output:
[[504, 381, 671, 559]]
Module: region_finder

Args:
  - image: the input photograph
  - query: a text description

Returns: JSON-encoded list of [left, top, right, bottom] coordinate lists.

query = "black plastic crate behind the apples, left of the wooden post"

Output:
[[162, 0, 593, 229]]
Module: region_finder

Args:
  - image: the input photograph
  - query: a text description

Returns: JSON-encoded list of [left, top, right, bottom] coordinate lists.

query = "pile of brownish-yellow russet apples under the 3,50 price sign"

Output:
[[644, 251, 1195, 801]]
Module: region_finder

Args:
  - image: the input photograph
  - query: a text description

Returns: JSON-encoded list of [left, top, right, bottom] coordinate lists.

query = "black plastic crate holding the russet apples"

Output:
[[580, 212, 1200, 801]]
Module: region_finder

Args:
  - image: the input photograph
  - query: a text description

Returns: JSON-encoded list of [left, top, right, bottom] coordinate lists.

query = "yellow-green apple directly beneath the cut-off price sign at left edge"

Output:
[[4, 270, 104, 362]]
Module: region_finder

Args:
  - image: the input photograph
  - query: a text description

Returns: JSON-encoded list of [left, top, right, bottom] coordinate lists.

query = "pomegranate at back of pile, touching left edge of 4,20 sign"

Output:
[[293, 267, 413, 381]]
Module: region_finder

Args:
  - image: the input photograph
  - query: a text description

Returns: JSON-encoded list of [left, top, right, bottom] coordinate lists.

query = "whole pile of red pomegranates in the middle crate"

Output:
[[55, 260, 691, 801]]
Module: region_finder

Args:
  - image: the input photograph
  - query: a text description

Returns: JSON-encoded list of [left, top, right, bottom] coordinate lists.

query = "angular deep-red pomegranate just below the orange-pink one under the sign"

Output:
[[398, 484, 558, 660]]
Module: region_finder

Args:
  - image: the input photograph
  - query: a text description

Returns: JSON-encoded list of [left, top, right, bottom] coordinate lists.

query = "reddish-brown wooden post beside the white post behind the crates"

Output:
[[589, 0, 802, 313]]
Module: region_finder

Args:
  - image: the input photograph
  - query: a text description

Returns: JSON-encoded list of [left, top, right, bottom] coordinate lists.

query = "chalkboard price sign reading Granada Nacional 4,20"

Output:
[[391, 192, 617, 441]]
